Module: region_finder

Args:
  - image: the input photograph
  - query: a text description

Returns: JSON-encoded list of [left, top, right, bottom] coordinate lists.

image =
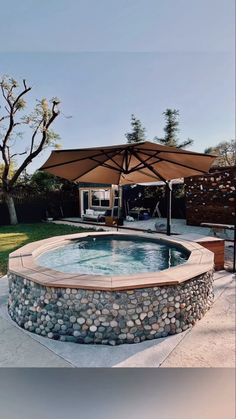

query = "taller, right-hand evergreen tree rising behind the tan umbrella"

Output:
[[154, 109, 193, 148]]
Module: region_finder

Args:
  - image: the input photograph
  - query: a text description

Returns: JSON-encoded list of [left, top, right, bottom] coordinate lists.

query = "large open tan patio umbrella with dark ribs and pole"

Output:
[[40, 141, 216, 235]]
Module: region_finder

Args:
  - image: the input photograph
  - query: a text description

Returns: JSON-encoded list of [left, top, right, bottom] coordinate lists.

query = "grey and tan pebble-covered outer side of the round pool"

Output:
[[8, 271, 213, 345]]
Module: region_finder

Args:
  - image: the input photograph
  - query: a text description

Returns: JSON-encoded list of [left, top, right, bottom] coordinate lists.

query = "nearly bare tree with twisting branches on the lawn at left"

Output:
[[0, 76, 60, 224]]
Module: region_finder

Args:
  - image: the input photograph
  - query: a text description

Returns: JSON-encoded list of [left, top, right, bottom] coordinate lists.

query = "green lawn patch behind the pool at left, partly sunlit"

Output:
[[0, 223, 92, 275]]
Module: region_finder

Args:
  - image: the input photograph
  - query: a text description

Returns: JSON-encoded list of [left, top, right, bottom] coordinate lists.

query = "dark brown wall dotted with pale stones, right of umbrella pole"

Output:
[[185, 167, 236, 225]]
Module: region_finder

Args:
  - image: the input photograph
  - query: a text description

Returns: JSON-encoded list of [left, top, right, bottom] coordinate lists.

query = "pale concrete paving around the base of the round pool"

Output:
[[0, 271, 235, 367]]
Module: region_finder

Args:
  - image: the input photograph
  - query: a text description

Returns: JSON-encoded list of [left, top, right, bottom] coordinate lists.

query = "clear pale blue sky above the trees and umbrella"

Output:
[[0, 0, 235, 171]]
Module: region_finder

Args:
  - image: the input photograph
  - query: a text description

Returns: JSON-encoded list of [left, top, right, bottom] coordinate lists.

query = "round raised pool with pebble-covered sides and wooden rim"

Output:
[[8, 232, 214, 345]]
